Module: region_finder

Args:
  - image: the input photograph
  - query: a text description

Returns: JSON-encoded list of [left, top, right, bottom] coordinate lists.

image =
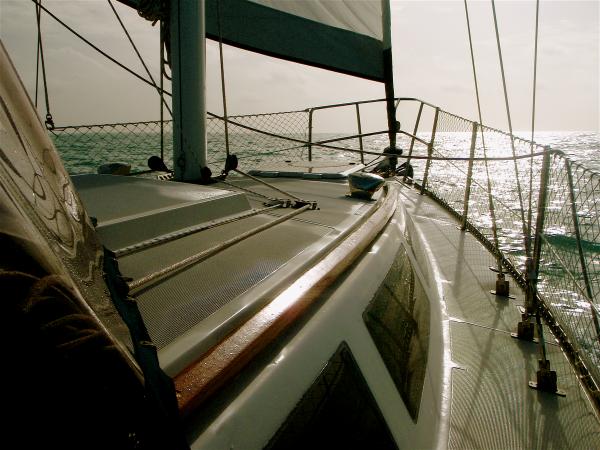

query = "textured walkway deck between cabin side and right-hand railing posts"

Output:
[[400, 181, 600, 449]]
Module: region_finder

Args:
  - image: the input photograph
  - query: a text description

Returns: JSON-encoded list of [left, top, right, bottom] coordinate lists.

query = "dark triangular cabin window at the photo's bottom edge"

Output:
[[265, 342, 398, 450]]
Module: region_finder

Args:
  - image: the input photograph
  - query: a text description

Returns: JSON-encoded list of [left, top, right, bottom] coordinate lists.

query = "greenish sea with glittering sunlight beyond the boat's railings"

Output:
[[53, 123, 600, 278]]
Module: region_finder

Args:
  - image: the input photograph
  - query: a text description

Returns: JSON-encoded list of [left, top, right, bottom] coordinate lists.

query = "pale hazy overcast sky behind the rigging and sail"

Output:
[[0, 0, 600, 132]]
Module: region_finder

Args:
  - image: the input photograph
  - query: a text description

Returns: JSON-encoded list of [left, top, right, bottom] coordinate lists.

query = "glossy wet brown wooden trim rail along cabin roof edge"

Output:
[[174, 186, 398, 416]]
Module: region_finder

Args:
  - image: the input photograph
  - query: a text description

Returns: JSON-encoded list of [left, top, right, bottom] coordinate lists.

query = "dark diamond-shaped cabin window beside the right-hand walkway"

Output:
[[363, 244, 429, 422]]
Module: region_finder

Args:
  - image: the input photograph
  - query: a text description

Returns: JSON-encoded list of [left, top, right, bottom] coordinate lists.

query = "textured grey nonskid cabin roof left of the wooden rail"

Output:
[[78, 174, 374, 374]]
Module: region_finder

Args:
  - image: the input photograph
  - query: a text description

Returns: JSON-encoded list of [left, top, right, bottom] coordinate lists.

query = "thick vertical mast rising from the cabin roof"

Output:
[[170, 0, 206, 181]]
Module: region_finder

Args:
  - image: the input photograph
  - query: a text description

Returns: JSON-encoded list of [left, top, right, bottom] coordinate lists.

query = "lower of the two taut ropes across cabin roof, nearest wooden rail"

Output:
[[128, 205, 310, 294]]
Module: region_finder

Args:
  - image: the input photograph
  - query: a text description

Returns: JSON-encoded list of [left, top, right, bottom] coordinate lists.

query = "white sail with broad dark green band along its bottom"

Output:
[[206, 0, 389, 81]]
